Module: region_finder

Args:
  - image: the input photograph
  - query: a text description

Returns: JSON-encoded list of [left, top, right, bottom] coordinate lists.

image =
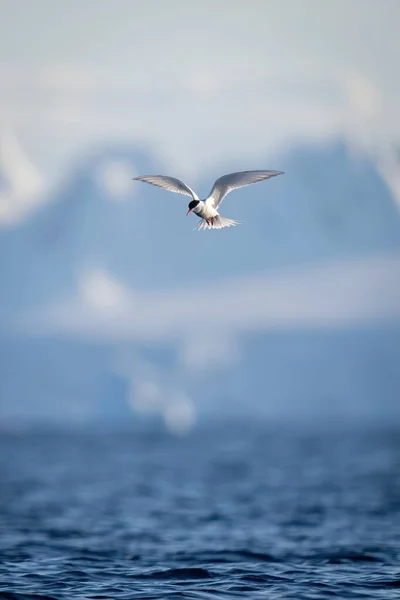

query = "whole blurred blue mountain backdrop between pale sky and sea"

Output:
[[0, 141, 400, 434]]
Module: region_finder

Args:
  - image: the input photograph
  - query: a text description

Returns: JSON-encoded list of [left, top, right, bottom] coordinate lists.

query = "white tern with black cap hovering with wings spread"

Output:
[[133, 171, 283, 229]]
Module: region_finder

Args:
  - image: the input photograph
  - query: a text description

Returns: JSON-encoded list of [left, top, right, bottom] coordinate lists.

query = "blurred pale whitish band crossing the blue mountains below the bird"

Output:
[[16, 253, 400, 346]]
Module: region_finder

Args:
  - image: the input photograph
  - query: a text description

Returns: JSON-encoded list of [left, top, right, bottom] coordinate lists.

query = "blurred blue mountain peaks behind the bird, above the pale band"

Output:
[[0, 145, 400, 307]]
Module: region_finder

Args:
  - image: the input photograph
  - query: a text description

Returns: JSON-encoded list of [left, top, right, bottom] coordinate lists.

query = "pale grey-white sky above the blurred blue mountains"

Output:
[[0, 0, 400, 220]]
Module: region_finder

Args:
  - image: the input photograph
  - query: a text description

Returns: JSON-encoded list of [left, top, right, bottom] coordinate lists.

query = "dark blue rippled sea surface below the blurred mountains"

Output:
[[0, 424, 400, 600]]
